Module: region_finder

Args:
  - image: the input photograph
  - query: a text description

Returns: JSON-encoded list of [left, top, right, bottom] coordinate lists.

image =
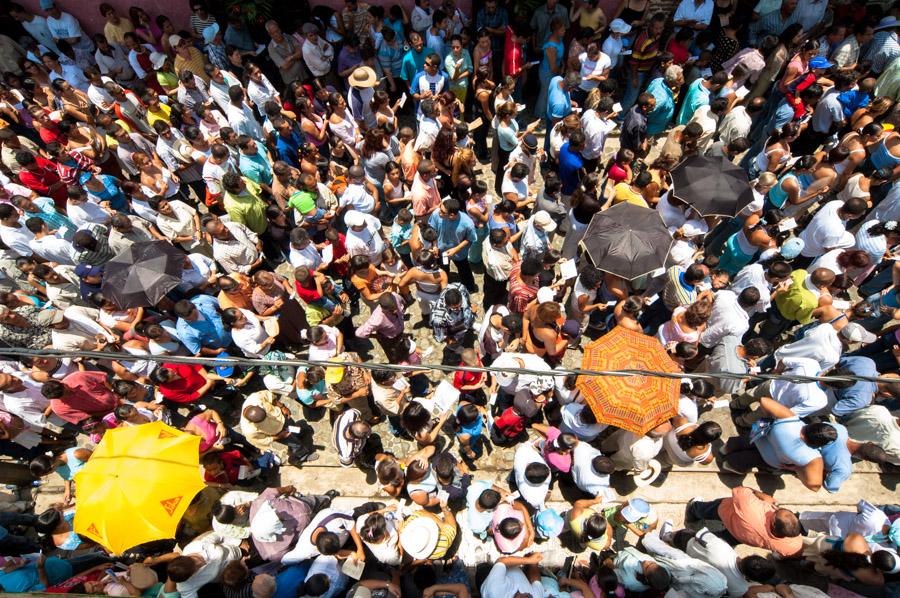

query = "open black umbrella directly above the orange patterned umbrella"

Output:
[[581, 202, 672, 280]]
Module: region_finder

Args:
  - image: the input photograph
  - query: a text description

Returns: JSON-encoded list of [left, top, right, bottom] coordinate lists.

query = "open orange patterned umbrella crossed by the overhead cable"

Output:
[[576, 326, 681, 435]]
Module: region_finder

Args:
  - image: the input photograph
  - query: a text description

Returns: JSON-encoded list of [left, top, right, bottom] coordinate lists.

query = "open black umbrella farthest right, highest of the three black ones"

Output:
[[672, 154, 753, 216]]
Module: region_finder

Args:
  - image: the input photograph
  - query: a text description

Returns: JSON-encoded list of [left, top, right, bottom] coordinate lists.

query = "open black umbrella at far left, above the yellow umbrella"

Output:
[[101, 241, 184, 309]]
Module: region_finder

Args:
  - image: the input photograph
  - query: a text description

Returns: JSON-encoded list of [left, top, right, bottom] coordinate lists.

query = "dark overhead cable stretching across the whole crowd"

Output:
[[0, 347, 900, 390]]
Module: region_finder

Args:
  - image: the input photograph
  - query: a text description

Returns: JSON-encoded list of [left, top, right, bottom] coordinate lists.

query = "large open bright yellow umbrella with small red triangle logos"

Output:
[[75, 422, 205, 554]]
